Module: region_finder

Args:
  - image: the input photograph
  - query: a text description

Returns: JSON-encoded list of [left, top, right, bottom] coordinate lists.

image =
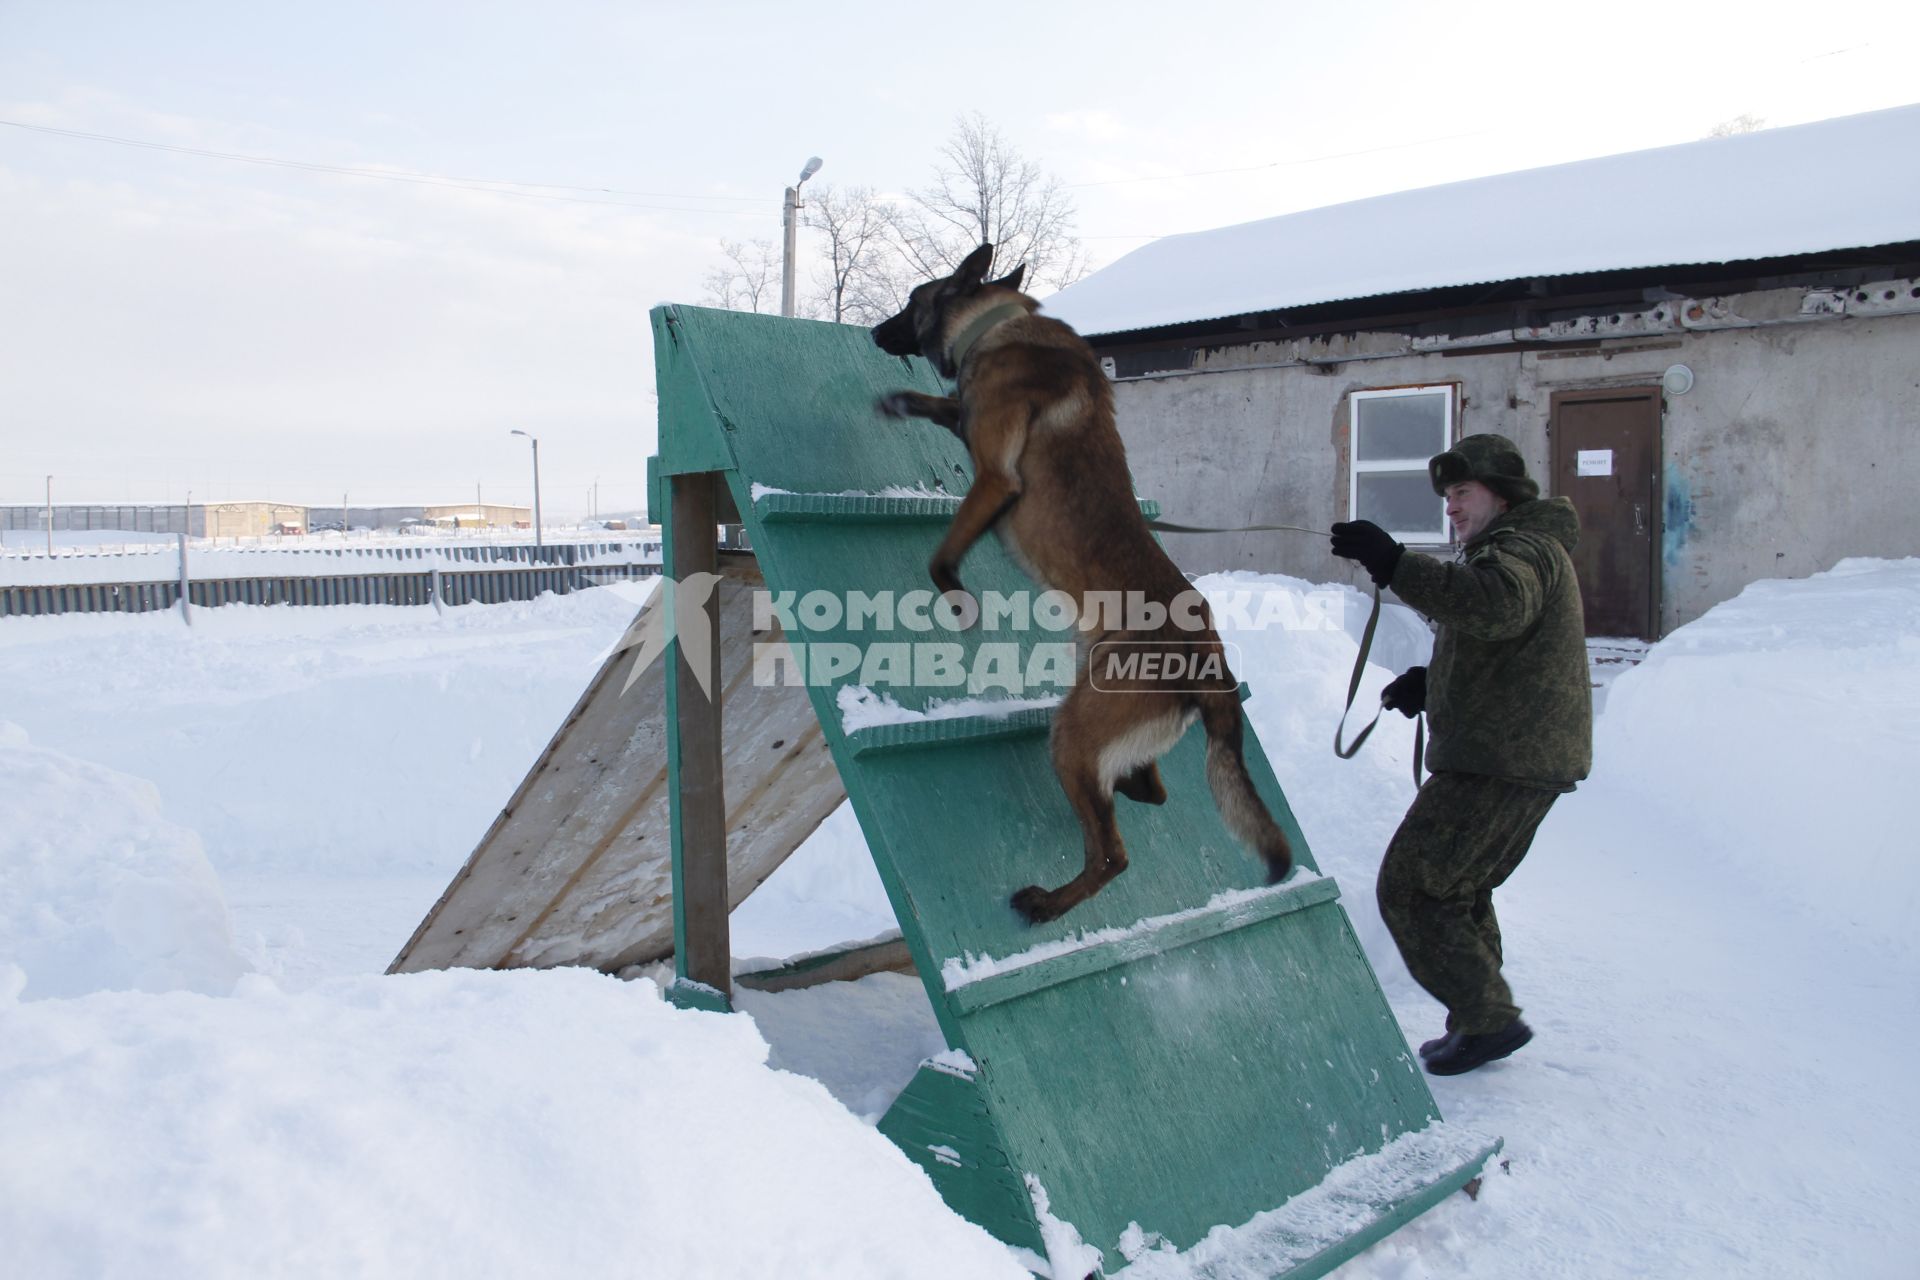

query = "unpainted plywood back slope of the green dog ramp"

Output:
[[388, 557, 847, 973]]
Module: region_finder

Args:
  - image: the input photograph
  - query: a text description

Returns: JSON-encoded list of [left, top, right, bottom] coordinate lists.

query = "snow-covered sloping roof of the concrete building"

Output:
[[1043, 106, 1920, 334]]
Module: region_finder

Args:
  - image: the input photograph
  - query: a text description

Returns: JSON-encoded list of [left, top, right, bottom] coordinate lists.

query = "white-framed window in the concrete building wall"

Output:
[[1348, 384, 1457, 543]]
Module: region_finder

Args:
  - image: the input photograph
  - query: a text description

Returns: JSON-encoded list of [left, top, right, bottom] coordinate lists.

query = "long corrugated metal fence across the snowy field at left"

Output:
[[0, 543, 660, 618]]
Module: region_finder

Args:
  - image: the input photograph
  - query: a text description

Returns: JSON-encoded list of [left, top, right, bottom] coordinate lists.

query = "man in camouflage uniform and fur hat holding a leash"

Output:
[[1332, 436, 1594, 1075]]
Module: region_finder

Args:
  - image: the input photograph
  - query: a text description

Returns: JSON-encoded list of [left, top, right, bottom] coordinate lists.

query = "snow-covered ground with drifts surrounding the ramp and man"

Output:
[[0, 560, 1920, 1280]]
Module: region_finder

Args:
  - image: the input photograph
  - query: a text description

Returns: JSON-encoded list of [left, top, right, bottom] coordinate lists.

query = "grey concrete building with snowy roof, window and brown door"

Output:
[[1044, 106, 1920, 637]]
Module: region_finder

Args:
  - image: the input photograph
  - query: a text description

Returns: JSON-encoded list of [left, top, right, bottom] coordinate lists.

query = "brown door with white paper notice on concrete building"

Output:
[[1548, 388, 1661, 639]]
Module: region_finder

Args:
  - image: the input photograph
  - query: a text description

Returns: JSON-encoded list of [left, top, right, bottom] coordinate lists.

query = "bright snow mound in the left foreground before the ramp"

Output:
[[0, 969, 1025, 1280]]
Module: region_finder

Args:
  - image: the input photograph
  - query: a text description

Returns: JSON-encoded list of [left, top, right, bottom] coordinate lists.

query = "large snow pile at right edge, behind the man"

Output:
[[1590, 558, 1920, 960]]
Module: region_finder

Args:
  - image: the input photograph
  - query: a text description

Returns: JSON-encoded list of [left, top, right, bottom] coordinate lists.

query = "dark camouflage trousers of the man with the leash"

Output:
[[1377, 773, 1559, 1034]]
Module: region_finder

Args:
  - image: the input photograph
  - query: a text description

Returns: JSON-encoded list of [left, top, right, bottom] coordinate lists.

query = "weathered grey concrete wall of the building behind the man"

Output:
[[1116, 290, 1920, 633]]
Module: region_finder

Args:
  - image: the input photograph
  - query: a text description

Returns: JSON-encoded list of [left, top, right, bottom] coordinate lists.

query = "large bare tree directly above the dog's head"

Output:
[[895, 111, 1089, 288]]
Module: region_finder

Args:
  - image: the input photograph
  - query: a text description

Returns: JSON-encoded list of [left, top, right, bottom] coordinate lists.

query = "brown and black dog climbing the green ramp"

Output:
[[874, 244, 1292, 923]]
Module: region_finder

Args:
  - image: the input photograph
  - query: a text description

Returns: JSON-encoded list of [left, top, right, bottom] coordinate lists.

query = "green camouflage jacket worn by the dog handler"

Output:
[[1392, 497, 1594, 791]]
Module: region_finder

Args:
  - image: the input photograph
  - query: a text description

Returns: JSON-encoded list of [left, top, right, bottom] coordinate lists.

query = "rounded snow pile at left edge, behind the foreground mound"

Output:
[[0, 722, 246, 1000]]
